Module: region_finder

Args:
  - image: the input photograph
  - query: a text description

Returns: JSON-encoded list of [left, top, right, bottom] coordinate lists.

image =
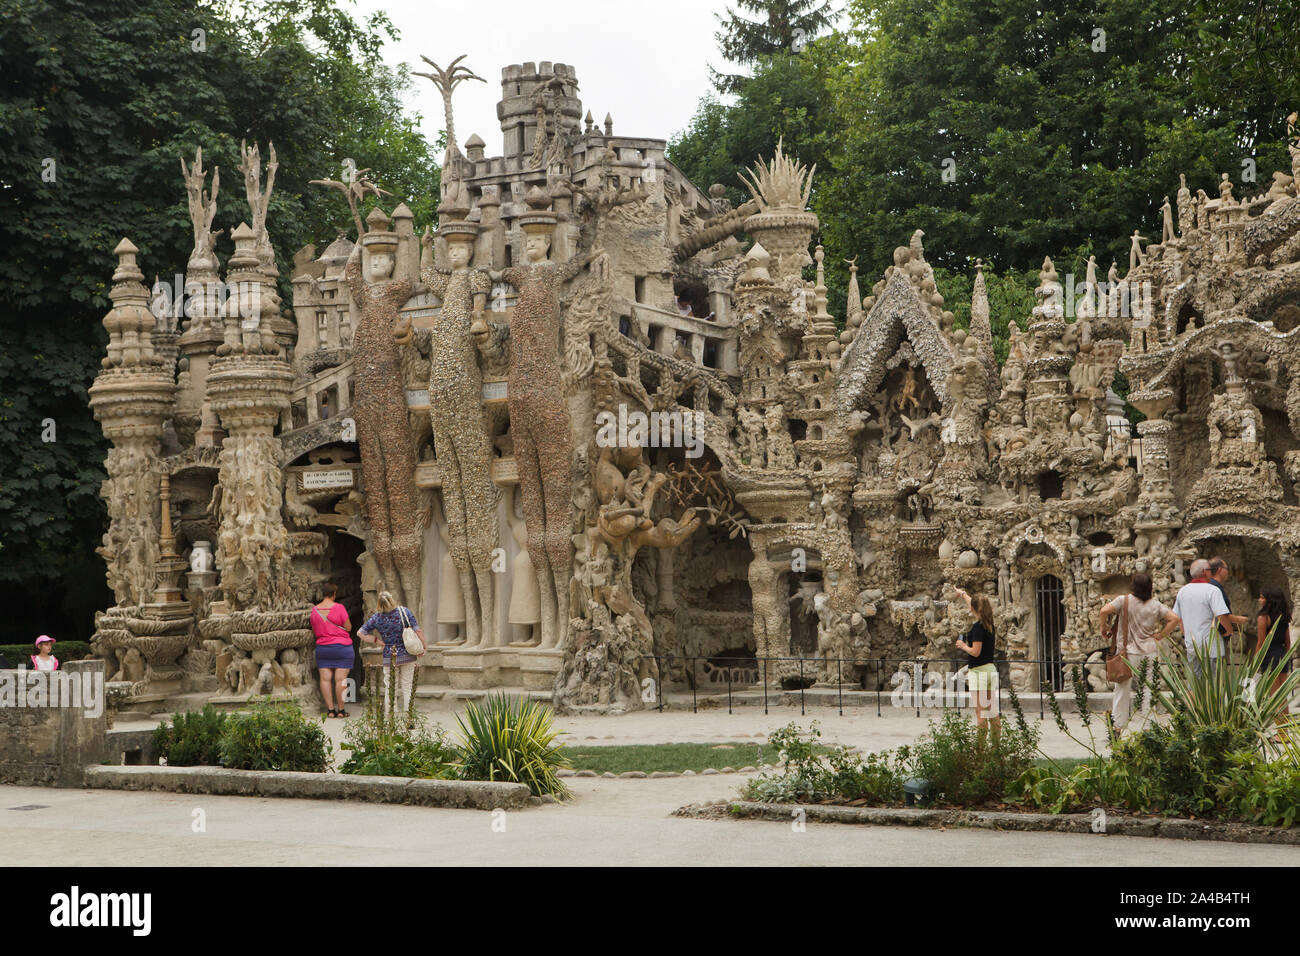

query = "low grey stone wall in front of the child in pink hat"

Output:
[[0, 659, 108, 787]]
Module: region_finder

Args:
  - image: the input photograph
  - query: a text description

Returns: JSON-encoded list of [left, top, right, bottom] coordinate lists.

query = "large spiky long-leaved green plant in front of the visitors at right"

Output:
[[1156, 622, 1300, 750]]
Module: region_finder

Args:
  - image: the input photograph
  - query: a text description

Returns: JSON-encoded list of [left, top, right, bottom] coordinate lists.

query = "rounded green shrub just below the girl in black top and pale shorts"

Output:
[[913, 710, 1039, 806]]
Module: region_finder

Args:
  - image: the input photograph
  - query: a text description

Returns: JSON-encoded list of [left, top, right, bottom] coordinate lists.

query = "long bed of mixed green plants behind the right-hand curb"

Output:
[[742, 656, 1300, 826]]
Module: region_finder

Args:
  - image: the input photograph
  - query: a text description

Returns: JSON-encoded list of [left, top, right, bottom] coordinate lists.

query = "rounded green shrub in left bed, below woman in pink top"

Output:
[[221, 701, 332, 774]]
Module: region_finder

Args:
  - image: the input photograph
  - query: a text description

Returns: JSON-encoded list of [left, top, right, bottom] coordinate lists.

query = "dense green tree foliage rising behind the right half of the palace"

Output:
[[668, 0, 1300, 340]]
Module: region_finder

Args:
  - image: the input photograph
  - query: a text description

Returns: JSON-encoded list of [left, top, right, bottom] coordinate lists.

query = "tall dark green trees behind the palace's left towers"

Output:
[[0, 0, 437, 639]]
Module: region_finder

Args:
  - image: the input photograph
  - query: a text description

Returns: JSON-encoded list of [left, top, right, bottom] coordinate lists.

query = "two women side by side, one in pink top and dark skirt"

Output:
[[311, 583, 424, 717]]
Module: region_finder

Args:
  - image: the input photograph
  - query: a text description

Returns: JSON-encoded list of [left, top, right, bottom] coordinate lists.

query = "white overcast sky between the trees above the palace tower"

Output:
[[356, 0, 743, 150]]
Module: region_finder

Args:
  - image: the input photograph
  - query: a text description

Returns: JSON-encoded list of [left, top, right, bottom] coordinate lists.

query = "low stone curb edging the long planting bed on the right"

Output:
[[691, 801, 1300, 847]]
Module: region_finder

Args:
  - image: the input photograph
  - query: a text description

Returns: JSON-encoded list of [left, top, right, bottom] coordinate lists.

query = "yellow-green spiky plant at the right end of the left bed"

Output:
[[456, 693, 569, 799]]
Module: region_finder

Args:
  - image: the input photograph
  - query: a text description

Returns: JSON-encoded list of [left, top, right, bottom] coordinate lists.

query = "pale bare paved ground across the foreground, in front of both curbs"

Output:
[[0, 777, 1300, 866]]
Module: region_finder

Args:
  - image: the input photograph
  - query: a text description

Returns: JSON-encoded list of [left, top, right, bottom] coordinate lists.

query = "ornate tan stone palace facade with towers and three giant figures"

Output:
[[91, 54, 1300, 709]]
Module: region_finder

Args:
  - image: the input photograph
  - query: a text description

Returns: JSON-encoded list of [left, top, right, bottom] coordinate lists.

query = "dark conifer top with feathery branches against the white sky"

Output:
[[710, 0, 833, 94]]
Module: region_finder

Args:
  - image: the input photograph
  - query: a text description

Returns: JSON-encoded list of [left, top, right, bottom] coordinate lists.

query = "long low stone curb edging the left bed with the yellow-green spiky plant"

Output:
[[85, 766, 532, 810]]
